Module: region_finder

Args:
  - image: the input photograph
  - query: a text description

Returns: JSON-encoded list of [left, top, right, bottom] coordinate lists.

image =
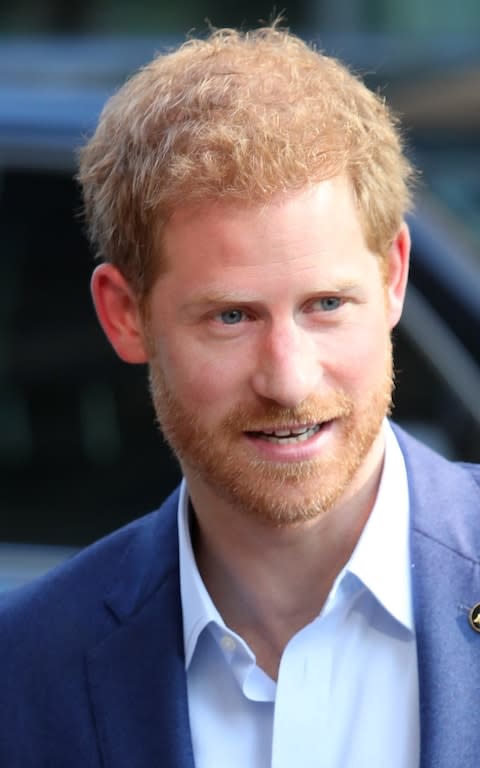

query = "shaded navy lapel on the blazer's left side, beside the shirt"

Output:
[[87, 492, 194, 768]]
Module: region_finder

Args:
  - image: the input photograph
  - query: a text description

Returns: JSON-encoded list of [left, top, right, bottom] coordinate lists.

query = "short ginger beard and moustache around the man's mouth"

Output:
[[150, 345, 393, 526]]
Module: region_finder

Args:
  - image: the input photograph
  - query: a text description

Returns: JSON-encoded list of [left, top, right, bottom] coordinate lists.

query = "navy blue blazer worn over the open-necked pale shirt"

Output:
[[0, 431, 480, 768]]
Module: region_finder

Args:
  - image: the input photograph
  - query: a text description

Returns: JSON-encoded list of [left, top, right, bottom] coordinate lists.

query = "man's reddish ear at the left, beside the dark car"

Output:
[[90, 264, 147, 363]]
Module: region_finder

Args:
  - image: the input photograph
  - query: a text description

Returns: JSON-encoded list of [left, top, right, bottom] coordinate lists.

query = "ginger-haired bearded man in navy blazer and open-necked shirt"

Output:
[[0, 26, 480, 768]]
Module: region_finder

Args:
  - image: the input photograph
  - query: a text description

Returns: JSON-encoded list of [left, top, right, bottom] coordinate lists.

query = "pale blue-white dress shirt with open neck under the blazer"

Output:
[[178, 422, 420, 768]]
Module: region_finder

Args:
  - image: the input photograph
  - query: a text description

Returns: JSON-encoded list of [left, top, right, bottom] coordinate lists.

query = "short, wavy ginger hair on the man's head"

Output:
[[78, 24, 412, 299]]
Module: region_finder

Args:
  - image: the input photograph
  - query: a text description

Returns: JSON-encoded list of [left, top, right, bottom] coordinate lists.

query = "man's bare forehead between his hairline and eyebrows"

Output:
[[162, 176, 364, 269]]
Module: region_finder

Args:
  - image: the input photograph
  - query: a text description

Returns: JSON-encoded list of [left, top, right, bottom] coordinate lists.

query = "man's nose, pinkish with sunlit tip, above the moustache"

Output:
[[252, 319, 322, 408]]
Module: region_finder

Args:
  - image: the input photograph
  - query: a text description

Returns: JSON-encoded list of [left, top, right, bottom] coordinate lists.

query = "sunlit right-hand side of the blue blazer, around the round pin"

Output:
[[397, 426, 480, 768]]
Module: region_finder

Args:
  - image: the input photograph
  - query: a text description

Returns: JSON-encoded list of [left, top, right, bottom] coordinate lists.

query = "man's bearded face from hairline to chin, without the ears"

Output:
[[148, 177, 404, 525]]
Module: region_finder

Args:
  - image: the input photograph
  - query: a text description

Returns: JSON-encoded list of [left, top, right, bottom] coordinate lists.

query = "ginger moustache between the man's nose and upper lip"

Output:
[[223, 392, 354, 432]]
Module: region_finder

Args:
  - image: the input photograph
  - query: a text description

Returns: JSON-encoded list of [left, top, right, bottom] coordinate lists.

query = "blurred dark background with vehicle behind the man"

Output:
[[0, 0, 480, 588]]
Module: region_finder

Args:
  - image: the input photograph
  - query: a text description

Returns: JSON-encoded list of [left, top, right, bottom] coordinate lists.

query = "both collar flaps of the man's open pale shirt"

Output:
[[178, 421, 413, 669]]
